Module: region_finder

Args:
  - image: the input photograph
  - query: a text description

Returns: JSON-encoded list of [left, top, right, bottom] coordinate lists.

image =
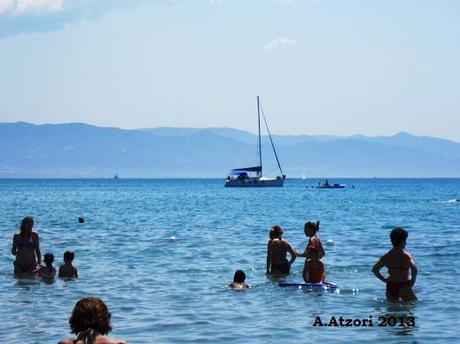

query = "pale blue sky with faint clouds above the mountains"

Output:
[[0, 0, 460, 142]]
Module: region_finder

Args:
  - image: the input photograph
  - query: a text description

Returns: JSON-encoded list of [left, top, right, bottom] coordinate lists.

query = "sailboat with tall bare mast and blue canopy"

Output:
[[225, 96, 286, 188]]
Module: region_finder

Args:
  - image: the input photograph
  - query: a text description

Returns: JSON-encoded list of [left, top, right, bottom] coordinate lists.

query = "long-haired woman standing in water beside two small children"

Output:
[[11, 216, 42, 274]]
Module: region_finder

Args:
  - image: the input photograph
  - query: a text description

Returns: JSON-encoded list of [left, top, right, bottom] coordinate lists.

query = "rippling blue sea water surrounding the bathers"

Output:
[[0, 179, 460, 343]]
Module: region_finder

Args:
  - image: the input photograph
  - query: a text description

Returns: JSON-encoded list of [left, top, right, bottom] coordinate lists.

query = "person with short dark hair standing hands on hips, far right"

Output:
[[372, 227, 417, 301]]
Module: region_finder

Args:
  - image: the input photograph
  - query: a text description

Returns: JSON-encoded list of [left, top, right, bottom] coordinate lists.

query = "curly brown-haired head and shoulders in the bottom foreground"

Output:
[[58, 297, 126, 344]]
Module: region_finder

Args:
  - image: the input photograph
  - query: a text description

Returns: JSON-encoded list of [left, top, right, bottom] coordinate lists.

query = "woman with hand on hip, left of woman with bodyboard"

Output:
[[267, 225, 297, 275]]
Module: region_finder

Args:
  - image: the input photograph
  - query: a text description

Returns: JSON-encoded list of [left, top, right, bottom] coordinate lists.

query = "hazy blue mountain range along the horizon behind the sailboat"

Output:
[[0, 122, 460, 178]]
